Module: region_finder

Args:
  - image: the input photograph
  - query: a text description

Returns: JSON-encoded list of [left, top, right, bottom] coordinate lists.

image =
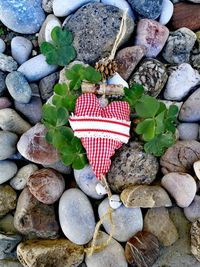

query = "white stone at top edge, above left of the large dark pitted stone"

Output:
[[53, 0, 100, 17]]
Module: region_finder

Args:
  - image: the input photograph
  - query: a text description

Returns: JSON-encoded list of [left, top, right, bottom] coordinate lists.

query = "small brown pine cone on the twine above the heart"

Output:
[[95, 59, 117, 79]]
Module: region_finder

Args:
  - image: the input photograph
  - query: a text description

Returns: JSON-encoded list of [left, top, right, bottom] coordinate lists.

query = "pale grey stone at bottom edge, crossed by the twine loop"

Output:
[[85, 231, 128, 267]]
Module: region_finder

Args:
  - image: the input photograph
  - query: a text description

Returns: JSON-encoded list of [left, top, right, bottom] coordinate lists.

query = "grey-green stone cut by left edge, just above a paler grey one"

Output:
[[0, 131, 18, 160]]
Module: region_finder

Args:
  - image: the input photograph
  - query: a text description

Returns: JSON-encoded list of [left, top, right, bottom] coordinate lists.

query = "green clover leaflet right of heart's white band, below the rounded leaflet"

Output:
[[135, 119, 155, 141]]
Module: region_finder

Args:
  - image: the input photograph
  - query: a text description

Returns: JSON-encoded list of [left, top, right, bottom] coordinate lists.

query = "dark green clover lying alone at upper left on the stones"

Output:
[[40, 26, 76, 66]]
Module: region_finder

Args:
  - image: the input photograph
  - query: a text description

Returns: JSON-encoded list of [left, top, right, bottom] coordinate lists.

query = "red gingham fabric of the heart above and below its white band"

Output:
[[75, 94, 130, 179]]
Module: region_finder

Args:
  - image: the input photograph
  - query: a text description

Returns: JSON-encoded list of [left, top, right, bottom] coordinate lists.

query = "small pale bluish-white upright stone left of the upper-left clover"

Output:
[[11, 36, 33, 65]]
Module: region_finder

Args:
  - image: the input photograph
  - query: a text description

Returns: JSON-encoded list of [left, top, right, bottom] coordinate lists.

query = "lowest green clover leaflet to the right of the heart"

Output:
[[144, 132, 175, 157]]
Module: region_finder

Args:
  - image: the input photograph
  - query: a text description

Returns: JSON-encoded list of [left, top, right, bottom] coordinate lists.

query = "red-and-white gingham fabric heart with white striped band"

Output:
[[69, 93, 130, 179]]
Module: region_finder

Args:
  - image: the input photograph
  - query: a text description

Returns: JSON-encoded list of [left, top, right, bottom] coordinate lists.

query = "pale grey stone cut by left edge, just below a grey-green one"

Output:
[[0, 160, 17, 184]]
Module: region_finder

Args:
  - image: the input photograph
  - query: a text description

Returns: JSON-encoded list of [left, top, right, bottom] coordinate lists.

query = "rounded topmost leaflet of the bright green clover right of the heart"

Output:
[[135, 95, 160, 118]]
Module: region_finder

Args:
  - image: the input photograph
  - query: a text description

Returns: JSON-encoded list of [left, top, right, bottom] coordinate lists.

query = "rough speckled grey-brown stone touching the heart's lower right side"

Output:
[[108, 142, 159, 193]]
